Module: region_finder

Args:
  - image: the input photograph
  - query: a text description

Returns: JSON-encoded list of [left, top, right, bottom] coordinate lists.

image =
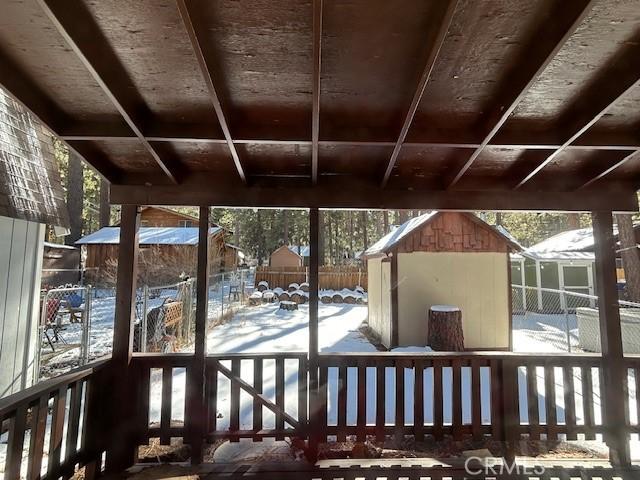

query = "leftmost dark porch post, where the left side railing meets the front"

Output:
[[106, 205, 140, 473]]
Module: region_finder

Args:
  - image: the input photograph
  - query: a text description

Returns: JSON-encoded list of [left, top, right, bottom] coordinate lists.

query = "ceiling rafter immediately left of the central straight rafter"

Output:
[[176, 0, 247, 183]]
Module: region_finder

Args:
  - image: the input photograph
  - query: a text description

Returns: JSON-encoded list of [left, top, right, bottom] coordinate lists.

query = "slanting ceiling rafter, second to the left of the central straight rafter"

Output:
[[37, 0, 179, 183]]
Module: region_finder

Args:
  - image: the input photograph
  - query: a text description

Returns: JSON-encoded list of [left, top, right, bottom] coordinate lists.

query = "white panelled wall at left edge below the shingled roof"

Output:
[[0, 217, 45, 397]]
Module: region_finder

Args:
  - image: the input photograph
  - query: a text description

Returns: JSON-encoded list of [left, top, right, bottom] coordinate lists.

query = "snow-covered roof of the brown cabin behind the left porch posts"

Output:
[[76, 227, 222, 245]]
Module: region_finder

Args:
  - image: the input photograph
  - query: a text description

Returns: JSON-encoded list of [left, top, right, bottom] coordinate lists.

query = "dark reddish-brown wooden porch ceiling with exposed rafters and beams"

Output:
[[0, 0, 640, 210]]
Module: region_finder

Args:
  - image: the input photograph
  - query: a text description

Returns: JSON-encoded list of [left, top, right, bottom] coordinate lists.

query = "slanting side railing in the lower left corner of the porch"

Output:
[[0, 361, 107, 480]]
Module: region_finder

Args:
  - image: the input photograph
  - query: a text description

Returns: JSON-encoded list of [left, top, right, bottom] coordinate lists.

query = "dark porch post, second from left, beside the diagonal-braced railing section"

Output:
[[187, 207, 209, 465]]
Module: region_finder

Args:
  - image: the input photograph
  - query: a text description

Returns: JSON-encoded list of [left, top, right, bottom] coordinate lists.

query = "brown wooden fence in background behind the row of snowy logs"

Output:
[[256, 266, 367, 290]]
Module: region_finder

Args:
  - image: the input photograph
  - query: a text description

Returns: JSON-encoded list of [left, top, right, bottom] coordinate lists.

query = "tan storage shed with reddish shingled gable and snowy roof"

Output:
[[364, 212, 519, 350]]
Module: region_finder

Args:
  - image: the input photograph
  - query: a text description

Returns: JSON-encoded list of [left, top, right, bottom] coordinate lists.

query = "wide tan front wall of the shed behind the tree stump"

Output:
[[398, 252, 511, 349]]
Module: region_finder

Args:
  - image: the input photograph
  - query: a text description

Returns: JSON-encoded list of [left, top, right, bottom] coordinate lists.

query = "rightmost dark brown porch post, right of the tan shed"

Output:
[[591, 211, 631, 466]]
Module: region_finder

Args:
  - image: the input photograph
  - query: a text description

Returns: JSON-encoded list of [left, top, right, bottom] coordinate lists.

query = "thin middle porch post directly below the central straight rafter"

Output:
[[307, 208, 322, 459]]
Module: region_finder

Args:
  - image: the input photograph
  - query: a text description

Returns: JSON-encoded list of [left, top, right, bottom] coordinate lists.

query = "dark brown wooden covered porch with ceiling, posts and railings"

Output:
[[0, 0, 640, 480]]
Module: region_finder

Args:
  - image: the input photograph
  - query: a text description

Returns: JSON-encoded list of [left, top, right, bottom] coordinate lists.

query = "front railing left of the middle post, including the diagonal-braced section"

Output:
[[133, 353, 308, 445]]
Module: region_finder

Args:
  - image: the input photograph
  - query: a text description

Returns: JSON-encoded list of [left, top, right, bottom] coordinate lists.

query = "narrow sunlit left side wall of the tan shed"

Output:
[[367, 258, 391, 347]]
